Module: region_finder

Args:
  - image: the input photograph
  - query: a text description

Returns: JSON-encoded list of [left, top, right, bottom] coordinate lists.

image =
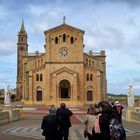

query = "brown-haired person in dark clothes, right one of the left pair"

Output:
[[56, 103, 73, 140]]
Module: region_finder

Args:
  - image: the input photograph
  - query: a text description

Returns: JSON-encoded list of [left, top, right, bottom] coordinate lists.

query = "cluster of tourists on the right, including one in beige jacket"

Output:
[[84, 101, 126, 140]]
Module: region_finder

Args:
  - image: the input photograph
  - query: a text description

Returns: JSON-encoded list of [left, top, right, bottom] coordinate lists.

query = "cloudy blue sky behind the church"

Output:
[[0, 0, 140, 95]]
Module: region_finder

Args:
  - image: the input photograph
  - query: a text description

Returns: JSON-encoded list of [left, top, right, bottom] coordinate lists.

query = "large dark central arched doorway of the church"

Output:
[[59, 80, 70, 99]]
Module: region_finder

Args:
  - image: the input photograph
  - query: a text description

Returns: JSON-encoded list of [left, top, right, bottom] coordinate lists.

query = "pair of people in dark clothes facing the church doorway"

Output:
[[41, 103, 73, 140]]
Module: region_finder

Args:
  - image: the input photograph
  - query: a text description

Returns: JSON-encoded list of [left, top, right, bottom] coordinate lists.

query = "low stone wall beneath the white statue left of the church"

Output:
[[0, 108, 23, 125]]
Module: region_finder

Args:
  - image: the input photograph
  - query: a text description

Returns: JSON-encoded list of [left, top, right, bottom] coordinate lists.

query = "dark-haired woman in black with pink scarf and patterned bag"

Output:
[[93, 101, 126, 140]]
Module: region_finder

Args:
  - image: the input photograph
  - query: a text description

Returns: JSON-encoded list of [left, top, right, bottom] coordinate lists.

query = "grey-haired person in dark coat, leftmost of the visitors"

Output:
[[41, 106, 58, 140]]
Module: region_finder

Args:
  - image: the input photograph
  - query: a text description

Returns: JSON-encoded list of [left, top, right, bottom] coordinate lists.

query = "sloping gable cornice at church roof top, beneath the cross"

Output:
[[44, 23, 85, 34]]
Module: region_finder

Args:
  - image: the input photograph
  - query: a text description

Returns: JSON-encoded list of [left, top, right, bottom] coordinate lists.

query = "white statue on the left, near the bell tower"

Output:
[[4, 85, 11, 106]]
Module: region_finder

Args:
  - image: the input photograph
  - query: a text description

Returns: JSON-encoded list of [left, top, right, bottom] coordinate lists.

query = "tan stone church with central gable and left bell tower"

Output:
[[17, 23, 107, 105]]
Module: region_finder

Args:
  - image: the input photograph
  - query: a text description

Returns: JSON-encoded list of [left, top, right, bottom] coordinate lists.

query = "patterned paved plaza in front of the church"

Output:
[[0, 106, 140, 140]]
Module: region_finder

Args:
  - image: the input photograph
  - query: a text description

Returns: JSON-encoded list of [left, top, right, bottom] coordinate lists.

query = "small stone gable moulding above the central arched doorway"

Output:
[[51, 67, 78, 75]]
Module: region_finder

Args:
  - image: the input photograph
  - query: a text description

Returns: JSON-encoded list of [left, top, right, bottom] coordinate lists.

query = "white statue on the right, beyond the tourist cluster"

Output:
[[127, 85, 135, 107]]
